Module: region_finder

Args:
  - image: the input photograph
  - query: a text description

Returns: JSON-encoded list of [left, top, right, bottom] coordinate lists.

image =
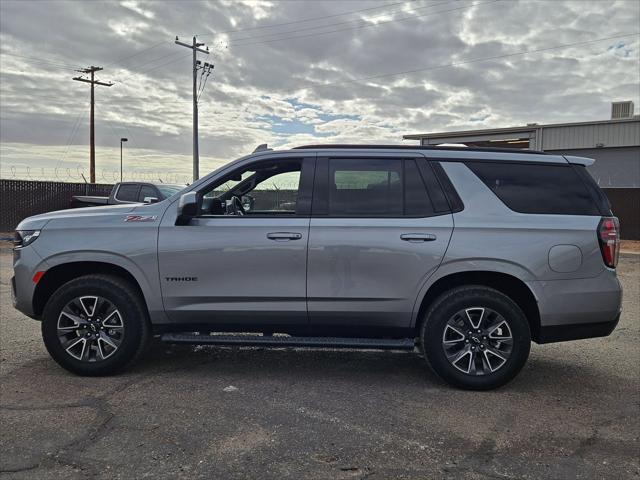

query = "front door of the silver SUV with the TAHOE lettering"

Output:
[[158, 155, 314, 330]]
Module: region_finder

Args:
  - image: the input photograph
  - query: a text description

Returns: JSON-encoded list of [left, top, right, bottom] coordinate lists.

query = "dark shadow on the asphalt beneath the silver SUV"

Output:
[[127, 341, 619, 395]]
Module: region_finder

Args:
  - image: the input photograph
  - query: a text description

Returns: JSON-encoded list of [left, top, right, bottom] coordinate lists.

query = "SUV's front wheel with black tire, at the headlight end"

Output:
[[42, 275, 151, 376]]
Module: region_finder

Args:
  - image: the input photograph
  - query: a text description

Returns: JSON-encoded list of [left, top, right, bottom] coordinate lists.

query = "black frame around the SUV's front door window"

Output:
[[194, 156, 316, 219]]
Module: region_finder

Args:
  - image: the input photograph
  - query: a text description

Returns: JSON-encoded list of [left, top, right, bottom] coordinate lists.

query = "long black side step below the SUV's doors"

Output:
[[160, 333, 415, 350]]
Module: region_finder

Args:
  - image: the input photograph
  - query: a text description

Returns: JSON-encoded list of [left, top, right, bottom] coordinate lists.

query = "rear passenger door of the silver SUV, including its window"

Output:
[[307, 152, 453, 335]]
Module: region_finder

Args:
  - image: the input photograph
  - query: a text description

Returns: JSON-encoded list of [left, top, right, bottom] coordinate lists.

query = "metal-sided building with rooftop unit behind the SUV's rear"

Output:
[[403, 102, 640, 188]]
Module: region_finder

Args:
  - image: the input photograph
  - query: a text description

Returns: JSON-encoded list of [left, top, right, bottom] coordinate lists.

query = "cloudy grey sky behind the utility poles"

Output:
[[0, 0, 640, 182]]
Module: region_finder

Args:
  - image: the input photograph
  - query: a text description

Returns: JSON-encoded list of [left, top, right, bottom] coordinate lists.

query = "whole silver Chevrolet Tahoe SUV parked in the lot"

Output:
[[8, 145, 622, 389]]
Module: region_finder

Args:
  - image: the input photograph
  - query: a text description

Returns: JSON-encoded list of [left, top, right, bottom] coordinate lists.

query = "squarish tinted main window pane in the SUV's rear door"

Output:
[[329, 159, 403, 216]]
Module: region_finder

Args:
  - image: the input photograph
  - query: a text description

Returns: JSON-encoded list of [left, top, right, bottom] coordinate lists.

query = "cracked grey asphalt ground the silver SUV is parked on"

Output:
[[0, 247, 640, 479]]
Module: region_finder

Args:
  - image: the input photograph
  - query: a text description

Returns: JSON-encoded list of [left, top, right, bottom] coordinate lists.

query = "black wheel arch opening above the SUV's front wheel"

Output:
[[33, 261, 148, 318]]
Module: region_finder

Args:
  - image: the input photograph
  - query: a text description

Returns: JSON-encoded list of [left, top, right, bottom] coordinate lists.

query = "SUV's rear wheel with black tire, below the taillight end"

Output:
[[420, 285, 531, 390]]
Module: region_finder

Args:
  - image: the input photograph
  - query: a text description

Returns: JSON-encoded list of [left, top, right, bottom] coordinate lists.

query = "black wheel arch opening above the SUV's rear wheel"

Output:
[[415, 270, 540, 342]]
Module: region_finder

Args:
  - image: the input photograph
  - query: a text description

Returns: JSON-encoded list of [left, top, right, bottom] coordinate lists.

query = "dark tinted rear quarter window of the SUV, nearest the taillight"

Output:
[[467, 162, 600, 215]]
